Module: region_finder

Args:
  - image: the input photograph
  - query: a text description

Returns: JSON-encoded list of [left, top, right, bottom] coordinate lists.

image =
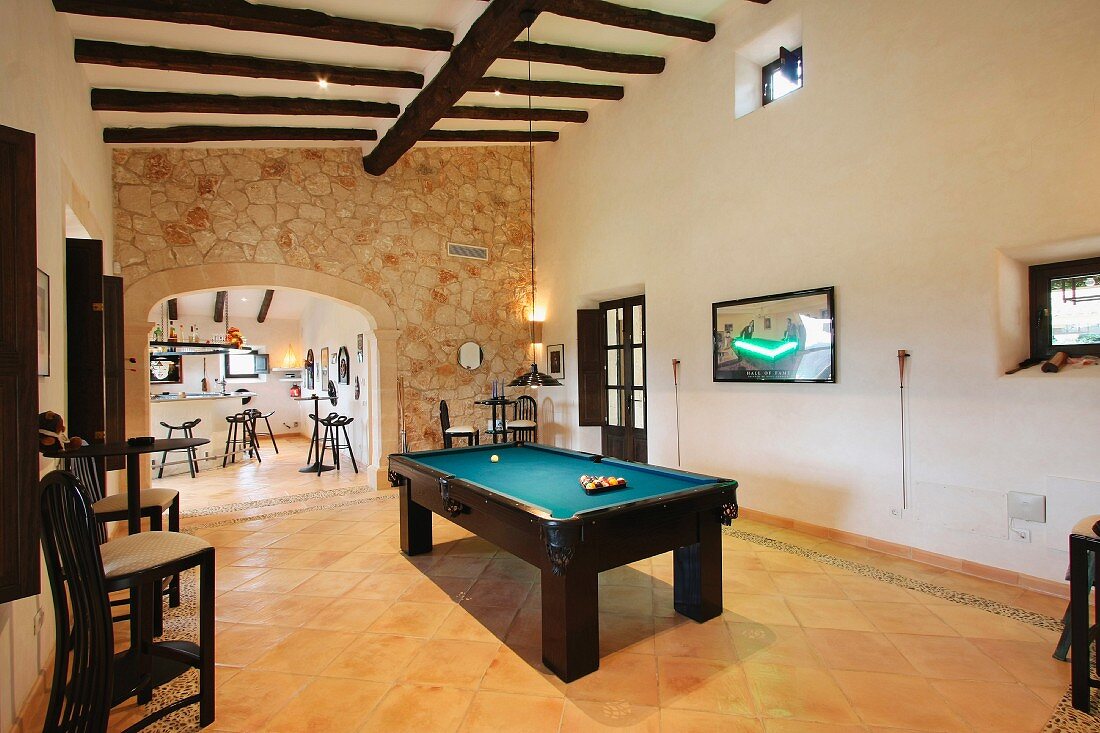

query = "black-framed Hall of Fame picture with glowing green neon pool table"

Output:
[[712, 287, 836, 382]]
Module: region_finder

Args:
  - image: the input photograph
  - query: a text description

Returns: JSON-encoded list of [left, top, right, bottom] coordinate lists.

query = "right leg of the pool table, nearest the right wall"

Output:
[[672, 512, 722, 623]]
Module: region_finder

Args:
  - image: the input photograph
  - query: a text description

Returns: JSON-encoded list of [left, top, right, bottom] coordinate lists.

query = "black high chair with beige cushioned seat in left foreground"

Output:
[[40, 471, 215, 733]]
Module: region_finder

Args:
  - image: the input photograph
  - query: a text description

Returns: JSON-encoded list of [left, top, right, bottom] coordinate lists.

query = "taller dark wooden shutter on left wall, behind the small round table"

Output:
[[65, 239, 107, 457]]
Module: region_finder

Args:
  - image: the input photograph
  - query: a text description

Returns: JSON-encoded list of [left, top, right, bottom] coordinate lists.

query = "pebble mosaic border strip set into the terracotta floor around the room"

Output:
[[146, 488, 1100, 733]]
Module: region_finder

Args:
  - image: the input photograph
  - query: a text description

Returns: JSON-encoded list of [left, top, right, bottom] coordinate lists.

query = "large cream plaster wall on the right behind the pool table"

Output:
[[536, 0, 1100, 579]]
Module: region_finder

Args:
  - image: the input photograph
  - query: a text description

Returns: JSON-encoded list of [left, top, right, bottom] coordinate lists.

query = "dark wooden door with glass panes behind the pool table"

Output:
[[600, 295, 648, 462]]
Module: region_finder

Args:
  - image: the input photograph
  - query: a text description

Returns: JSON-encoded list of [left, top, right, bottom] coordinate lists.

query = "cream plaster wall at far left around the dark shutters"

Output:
[[0, 0, 113, 731]]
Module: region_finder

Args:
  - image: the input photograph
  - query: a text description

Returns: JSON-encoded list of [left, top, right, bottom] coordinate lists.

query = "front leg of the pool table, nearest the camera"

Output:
[[542, 553, 600, 682]]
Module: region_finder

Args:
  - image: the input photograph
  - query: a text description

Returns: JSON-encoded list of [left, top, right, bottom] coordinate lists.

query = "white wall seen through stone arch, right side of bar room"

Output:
[[298, 298, 381, 477]]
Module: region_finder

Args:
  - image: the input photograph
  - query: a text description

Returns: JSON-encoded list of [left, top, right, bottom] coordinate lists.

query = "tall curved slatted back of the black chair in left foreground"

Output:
[[39, 471, 114, 733]]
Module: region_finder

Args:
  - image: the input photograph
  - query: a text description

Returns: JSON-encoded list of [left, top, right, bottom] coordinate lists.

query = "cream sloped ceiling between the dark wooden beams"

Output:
[[55, 0, 746, 149]]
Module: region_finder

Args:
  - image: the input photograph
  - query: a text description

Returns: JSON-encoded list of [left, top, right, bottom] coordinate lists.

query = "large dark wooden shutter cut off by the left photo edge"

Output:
[[0, 125, 40, 603]]
